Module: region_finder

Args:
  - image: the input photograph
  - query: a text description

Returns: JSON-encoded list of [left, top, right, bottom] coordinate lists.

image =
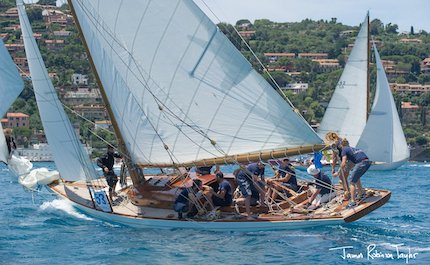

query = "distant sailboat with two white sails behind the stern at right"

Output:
[[318, 15, 409, 170]]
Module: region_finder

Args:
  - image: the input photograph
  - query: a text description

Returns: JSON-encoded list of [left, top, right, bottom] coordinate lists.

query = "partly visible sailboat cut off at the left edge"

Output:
[[0, 39, 32, 177]]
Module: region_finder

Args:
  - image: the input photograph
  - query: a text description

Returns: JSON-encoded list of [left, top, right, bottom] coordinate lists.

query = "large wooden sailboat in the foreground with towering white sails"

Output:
[[17, 0, 391, 231]]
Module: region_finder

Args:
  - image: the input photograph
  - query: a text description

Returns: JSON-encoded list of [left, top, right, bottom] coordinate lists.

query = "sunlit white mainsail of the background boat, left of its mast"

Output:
[[318, 15, 369, 146]]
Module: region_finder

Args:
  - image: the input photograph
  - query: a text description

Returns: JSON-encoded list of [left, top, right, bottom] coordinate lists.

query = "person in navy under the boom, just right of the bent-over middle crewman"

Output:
[[267, 158, 299, 200]]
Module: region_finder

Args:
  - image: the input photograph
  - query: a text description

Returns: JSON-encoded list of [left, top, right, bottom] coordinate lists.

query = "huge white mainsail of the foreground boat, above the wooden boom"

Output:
[[70, 0, 321, 164]]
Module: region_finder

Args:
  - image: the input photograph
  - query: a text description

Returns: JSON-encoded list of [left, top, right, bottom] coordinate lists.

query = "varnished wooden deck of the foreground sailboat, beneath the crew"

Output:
[[50, 173, 391, 225]]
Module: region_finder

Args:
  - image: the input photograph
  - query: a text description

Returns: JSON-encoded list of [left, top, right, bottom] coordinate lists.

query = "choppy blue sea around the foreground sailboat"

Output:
[[0, 163, 430, 265]]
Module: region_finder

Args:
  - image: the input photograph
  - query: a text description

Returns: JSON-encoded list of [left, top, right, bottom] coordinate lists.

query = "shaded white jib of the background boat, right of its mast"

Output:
[[358, 45, 409, 169]]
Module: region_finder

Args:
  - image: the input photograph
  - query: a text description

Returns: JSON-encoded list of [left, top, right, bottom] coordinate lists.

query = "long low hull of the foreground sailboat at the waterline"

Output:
[[45, 178, 391, 231]]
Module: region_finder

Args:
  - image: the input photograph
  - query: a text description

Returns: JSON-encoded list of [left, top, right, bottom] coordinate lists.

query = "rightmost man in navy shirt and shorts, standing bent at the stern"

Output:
[[339, 139, 372, 207]]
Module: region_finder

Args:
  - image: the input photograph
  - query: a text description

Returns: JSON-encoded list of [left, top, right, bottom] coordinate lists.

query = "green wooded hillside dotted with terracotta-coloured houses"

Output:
[[0, 1, 430, 157]]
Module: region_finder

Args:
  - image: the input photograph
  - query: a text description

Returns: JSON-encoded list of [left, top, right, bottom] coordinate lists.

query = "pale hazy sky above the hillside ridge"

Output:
[[25, 0, 430, 32]]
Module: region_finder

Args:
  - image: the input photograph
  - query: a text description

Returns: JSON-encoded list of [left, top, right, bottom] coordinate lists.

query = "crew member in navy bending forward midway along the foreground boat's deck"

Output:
[[235, 162, 265, 219]]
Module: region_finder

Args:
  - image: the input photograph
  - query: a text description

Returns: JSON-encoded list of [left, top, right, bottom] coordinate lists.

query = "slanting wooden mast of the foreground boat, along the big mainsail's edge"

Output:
[[67, 0, 142, 186]]
